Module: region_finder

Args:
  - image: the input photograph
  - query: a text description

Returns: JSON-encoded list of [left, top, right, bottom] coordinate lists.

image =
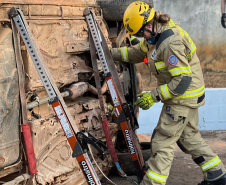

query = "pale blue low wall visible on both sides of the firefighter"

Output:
[[137, 88, 226, 134]]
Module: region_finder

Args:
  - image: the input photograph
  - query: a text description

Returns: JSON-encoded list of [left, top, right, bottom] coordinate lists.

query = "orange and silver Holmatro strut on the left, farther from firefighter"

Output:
[[9, 8, 107, 185]]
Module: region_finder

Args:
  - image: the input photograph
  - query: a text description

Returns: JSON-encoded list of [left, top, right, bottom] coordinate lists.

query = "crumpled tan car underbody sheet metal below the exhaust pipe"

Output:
[[31, 97, 117, 185]]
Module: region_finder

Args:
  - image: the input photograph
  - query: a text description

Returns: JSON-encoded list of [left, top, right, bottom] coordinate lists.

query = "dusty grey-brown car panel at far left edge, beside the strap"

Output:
[[0, 25, 20, 171]]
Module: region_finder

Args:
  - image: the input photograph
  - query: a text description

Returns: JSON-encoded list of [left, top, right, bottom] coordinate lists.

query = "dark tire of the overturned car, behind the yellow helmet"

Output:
[[97, 0, 153, 21]]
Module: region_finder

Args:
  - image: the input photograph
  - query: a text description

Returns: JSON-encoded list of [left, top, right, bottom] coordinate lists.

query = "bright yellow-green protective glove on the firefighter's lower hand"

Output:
[[134, 92, 155, 110]]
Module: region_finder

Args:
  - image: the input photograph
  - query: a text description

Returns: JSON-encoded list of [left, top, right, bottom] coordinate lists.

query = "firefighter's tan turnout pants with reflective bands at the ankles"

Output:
[[141, 105, 226, 185]]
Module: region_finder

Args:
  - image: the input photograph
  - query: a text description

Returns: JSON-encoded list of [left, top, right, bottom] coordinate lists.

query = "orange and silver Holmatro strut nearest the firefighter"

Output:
[[84, 8, 145, 184]]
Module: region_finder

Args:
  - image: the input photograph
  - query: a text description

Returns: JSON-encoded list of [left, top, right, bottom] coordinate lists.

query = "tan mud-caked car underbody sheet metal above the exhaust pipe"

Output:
[[23, 20, 107, 91]]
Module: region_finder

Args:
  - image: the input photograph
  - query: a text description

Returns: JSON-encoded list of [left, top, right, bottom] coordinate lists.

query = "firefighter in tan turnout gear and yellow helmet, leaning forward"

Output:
[[111, 1, 226, 185]]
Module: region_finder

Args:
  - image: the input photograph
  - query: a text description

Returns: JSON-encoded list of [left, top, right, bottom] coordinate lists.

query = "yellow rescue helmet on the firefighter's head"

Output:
[[123, 1, 155, 36]]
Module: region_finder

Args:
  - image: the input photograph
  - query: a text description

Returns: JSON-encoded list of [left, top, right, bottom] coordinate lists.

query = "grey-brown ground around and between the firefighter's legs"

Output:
[[102, 131, 226, 185]]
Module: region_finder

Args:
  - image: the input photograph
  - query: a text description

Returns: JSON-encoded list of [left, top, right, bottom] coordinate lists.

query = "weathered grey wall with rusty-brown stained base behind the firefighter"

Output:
[[154, 0, 226, 72]]
